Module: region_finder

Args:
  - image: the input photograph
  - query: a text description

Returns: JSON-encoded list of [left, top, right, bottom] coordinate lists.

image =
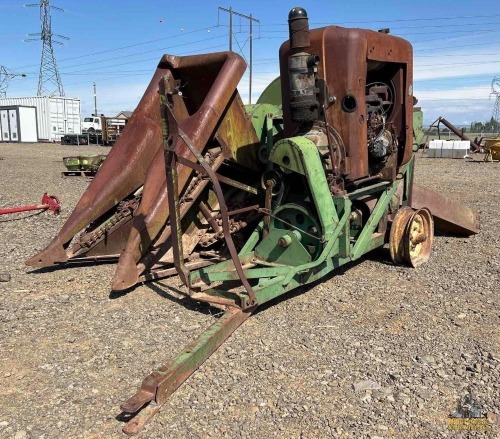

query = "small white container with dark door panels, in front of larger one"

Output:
[[0, 106, 38, 142]]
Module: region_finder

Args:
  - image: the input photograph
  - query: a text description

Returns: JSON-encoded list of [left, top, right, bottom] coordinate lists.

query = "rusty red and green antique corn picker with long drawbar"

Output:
[[27, 8, 479, 434]]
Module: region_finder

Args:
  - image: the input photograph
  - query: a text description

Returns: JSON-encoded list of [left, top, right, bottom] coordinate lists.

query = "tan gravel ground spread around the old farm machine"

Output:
[[0, 144, 500, 439]]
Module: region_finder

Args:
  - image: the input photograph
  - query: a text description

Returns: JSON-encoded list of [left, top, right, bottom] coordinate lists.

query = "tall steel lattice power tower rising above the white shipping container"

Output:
[[25, 0, 69, 96]]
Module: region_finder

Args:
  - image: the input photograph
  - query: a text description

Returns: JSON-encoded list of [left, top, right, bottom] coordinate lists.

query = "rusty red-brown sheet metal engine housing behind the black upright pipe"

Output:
[[280, 26, 413, 180]]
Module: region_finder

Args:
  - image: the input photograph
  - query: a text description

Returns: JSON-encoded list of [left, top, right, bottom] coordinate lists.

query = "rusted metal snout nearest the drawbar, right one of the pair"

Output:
[[112, 52, 251, 290]]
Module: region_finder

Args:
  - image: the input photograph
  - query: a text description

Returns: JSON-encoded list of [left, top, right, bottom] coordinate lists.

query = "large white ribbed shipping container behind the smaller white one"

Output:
[[0, 96, 82, 142]]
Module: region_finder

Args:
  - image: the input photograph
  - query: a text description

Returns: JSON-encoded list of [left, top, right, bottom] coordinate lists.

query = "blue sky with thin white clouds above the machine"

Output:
[[0, 0, 500, 124]]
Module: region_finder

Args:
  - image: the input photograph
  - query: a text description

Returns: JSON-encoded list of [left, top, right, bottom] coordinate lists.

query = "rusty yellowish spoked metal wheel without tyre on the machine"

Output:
[[389, 207, 434, 267]]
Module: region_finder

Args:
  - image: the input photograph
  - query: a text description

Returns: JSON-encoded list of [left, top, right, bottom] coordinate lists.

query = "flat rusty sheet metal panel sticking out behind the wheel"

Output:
[[410, 184, 480, 236]]
